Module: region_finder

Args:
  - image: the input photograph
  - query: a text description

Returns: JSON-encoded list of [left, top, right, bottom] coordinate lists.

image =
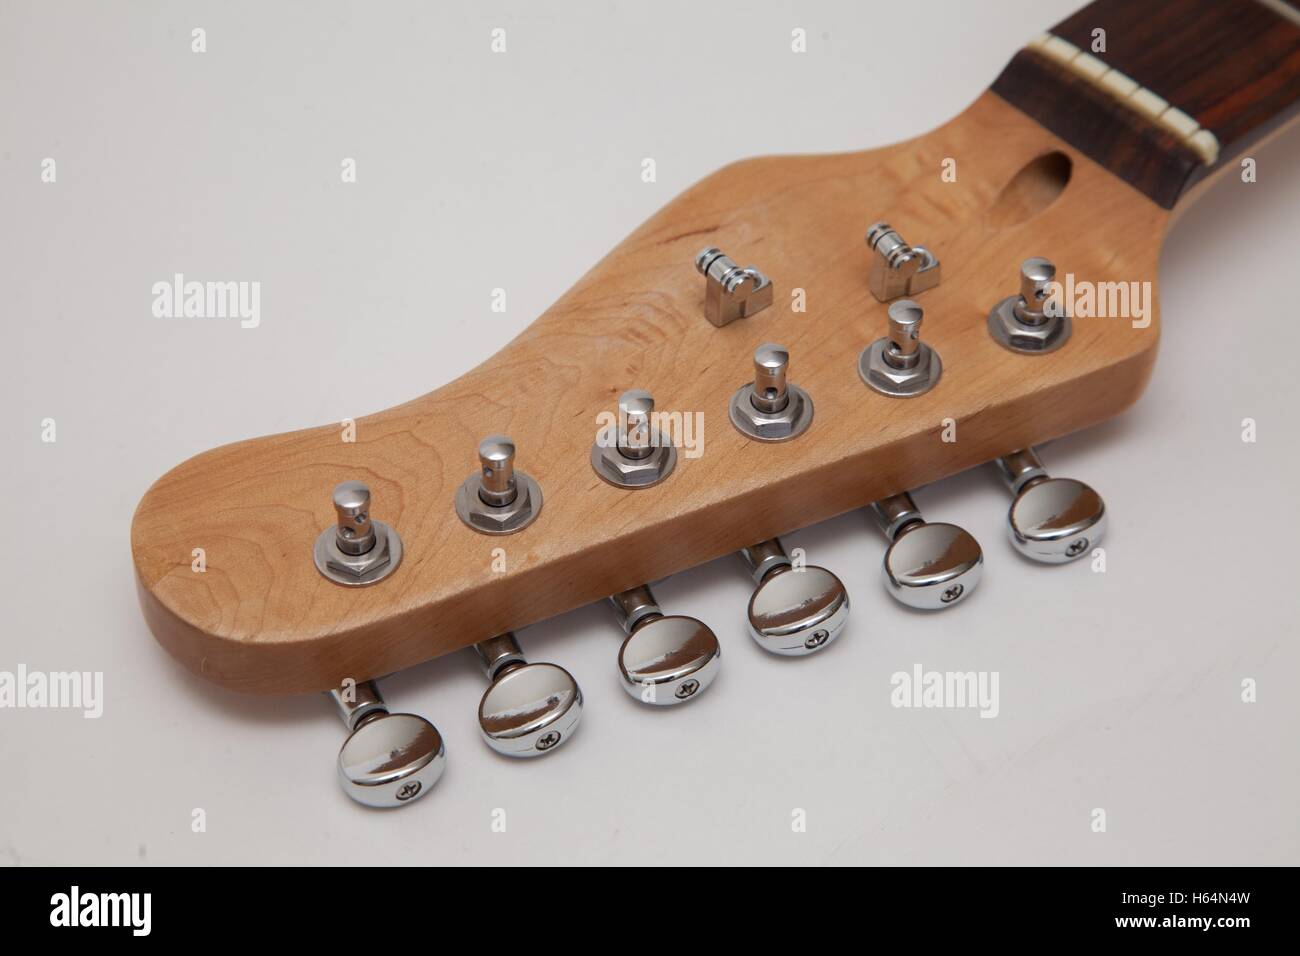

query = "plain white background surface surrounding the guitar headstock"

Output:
[[0, 0, 1300, 865]]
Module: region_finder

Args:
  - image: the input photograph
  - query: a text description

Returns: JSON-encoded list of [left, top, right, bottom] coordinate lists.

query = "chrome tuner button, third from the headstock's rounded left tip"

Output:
[[610, 584, 723, 708]]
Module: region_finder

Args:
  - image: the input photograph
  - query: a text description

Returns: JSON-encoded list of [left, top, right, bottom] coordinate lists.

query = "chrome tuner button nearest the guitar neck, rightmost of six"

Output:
[[997, 449, 1106, 564]]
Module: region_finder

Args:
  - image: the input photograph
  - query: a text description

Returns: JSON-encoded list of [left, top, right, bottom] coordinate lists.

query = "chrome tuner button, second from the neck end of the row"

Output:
[[871, 492, 984, 610]]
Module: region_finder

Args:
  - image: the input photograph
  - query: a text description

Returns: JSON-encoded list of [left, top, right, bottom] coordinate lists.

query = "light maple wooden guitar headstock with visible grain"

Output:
[[131, 94, 1167, 693]]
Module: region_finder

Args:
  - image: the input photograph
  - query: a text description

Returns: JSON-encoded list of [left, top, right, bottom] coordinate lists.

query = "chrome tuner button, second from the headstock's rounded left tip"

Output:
[[475, 632, 582, 757]]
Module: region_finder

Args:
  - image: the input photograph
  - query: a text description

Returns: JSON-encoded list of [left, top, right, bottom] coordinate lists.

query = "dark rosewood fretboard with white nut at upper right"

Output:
[[993, 0, 1300, 209]]
